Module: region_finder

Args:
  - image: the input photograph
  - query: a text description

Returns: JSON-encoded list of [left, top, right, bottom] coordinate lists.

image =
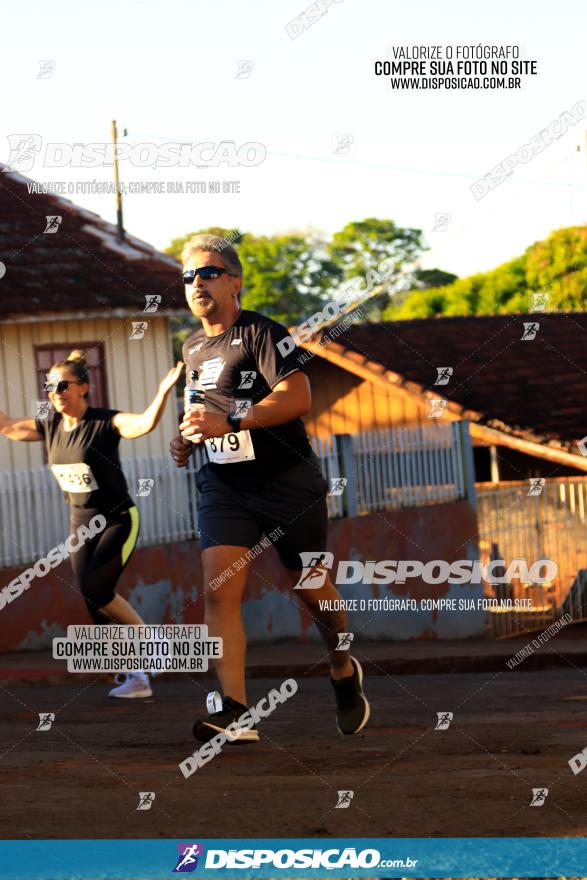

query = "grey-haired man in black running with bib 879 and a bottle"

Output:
[[170, 235, 369, 742]]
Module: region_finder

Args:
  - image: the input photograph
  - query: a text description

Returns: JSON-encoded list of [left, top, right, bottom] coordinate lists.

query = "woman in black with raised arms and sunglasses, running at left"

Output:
[[0, 350, 183, 699]]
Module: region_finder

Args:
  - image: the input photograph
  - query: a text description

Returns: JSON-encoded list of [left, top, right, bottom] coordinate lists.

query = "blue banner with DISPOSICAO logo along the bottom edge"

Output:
[[0, 837, 587, 880]]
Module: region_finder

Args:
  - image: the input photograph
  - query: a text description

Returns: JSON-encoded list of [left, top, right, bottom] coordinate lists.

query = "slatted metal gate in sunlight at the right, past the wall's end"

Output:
[[477, 477, 587, 637]]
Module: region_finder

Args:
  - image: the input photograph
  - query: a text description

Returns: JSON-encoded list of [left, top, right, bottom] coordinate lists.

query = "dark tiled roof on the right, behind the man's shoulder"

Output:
[[324, 312, 587, 443]]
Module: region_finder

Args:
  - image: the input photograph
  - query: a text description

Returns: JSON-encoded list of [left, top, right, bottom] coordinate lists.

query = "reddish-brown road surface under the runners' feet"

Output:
[[0, 668, 587, 839]]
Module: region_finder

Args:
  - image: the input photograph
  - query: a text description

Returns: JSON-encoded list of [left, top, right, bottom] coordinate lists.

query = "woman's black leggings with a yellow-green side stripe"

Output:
[[69, 507, 139, 623]]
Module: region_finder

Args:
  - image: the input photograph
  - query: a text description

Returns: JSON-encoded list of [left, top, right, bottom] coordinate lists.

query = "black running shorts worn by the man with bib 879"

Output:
[[196, 453, 329, 571]]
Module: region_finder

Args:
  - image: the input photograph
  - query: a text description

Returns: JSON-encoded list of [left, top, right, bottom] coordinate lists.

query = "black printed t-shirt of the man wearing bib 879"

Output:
[[183, 310, 311, 488]]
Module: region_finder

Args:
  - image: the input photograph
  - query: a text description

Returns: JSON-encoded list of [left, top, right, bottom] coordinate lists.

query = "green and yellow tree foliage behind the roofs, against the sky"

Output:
[[162, 217, 587, 326]]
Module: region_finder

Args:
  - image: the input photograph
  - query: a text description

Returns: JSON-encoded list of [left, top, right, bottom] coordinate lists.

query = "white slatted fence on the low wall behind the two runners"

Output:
[[0, 422, 474, 568]]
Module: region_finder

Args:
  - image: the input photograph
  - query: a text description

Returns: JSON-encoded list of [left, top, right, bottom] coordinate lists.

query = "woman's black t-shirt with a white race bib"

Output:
[[35, 406, 134, 514]]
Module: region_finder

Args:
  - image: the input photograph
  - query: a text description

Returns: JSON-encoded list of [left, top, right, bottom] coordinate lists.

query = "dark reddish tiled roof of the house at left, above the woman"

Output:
[[0, 165, 186, 319]]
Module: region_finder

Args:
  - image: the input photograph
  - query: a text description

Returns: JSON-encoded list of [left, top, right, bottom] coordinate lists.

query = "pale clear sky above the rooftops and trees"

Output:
[[0, 0, 587, 275]]
